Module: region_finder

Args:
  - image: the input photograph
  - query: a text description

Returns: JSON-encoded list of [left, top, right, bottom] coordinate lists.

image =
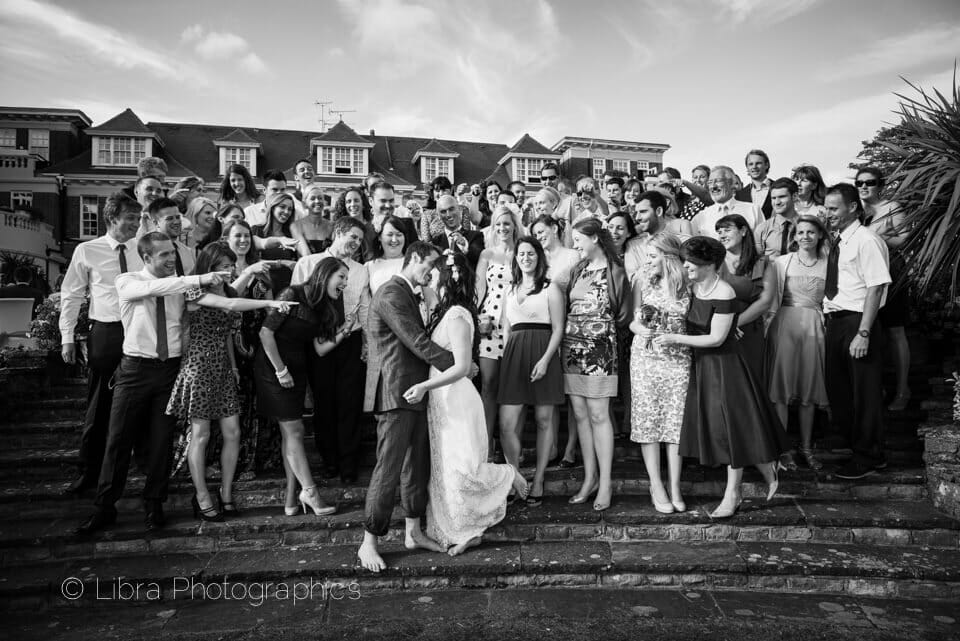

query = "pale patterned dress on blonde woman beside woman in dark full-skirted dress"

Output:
[[630, 279, 690, 443]]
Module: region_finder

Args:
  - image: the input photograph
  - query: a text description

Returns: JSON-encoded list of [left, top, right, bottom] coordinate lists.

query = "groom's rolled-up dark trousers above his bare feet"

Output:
[[363, 410, 430, 536]]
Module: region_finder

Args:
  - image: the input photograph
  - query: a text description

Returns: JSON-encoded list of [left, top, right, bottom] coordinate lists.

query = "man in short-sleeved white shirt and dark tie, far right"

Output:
[[823, 184, 890, 479]]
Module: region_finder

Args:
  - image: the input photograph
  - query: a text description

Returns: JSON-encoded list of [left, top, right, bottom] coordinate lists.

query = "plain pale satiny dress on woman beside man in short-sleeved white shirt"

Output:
[[766, 259, 829, 407]]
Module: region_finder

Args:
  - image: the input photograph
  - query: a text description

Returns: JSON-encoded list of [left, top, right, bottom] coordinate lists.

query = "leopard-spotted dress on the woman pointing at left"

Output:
[[166, 289, 240, 421]]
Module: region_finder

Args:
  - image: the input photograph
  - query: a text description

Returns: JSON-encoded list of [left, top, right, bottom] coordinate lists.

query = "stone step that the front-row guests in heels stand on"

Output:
[[0, 495, 960, 567]]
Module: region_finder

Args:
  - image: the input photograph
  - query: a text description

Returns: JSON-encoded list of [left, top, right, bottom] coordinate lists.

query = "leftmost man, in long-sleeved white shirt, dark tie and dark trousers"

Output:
[[60, 192, 143, 494]]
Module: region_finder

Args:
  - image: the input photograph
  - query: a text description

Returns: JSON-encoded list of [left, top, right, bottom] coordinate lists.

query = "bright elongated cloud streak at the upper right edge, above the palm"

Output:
[[821, 25, 960, 81]]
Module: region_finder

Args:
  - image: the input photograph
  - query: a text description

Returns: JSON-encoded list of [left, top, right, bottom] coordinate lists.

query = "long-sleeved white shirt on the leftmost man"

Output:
[[60, 234, 143, 345]]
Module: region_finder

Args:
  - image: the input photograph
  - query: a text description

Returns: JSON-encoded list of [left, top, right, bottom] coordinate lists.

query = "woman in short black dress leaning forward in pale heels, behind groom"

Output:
[[253, 258, 347, 516]]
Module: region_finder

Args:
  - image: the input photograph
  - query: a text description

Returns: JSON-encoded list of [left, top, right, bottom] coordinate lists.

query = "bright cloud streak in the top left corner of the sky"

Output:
[[0, 0, 191, 80]]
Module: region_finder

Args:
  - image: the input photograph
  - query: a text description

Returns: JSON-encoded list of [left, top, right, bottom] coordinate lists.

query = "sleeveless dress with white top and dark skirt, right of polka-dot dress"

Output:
[[497, 283, 566, 405]]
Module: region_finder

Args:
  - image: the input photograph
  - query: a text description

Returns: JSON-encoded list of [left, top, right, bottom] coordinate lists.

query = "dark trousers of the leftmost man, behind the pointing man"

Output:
[[79, 321, 123, 486]]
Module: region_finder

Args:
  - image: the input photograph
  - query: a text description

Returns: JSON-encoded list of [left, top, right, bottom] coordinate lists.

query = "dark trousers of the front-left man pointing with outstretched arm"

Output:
[[94, 356, 180, 507]]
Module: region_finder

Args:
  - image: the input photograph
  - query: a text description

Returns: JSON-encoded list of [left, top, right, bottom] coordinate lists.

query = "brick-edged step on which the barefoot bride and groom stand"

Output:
[[7, 541, 960, 610]]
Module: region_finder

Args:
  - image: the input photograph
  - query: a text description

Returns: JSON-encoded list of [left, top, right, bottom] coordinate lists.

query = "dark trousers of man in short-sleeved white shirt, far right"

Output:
[[825, 313, 883, 465]]
